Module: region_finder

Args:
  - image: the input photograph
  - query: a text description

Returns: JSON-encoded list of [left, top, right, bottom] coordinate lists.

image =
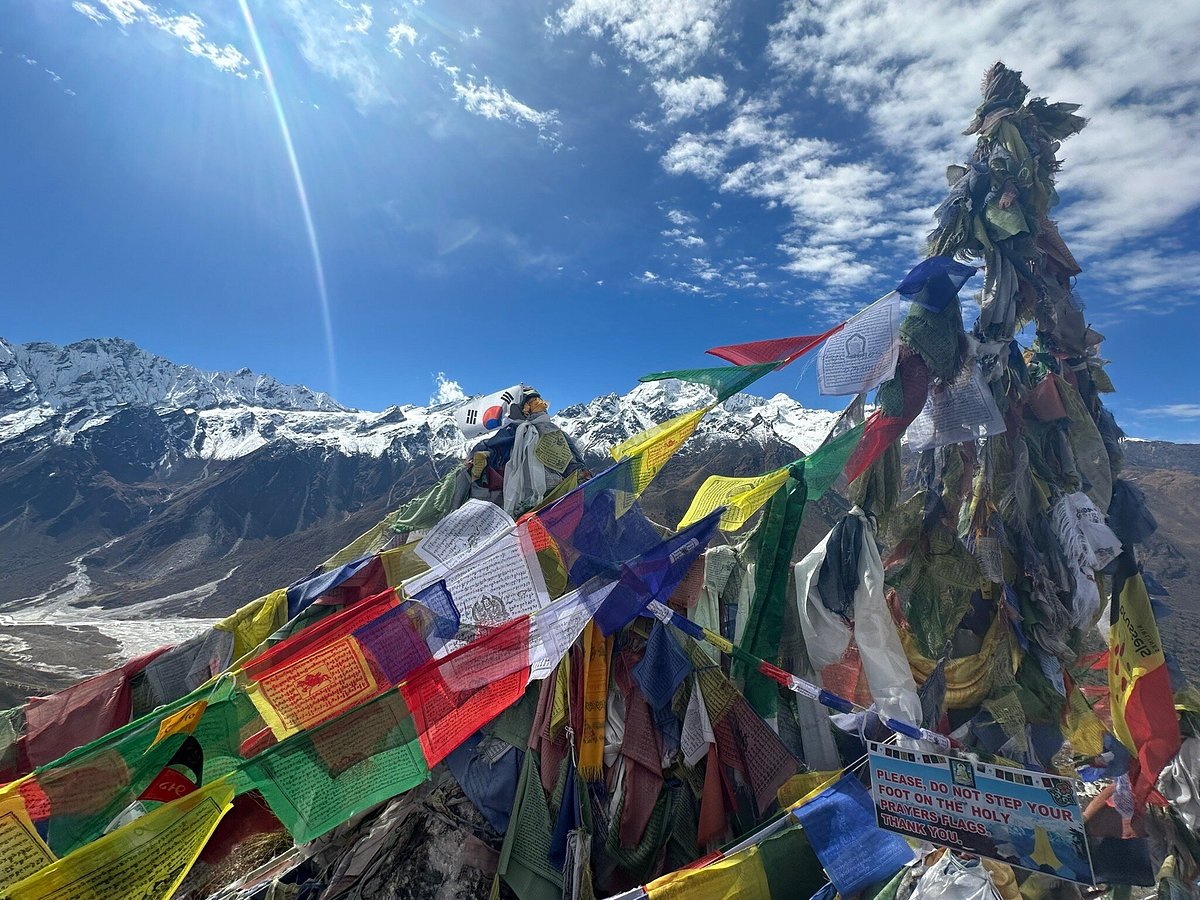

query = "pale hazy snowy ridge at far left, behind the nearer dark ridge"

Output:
[[0, 337, 346, 415]]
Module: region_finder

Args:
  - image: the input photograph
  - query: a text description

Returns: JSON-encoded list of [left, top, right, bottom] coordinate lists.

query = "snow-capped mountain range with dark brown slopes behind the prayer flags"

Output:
[[0, 338, 834, 616]]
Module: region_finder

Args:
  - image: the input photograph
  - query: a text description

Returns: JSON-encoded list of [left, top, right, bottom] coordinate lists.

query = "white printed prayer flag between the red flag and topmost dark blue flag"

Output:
[[817, 292, 904, 395]]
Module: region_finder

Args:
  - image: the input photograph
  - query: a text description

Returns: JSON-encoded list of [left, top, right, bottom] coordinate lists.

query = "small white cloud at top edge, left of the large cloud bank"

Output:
[[556, 0, 728, 72]]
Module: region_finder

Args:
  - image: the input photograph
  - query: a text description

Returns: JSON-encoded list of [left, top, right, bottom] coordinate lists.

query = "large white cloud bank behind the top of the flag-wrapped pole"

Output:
[[768, 0, 1200, 267]]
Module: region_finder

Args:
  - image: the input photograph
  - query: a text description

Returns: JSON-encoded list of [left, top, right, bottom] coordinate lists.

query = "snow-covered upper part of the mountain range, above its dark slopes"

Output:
[[0, 338, 836, 462]]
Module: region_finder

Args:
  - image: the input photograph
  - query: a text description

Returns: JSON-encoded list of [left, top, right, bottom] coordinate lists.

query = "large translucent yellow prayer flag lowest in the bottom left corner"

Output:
[[5, 780, 234, 900]]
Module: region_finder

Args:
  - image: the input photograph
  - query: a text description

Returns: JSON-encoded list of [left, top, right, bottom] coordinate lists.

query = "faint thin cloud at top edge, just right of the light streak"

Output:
[[278, 0, 394, 112]]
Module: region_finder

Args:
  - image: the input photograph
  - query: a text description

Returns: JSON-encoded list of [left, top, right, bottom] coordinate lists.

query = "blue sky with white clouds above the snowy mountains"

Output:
[[0, 0, 1200, 440]]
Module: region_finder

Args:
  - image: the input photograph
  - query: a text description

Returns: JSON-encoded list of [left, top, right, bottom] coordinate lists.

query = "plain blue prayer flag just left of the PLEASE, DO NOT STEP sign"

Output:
[[792, 773, 914, 896]]
